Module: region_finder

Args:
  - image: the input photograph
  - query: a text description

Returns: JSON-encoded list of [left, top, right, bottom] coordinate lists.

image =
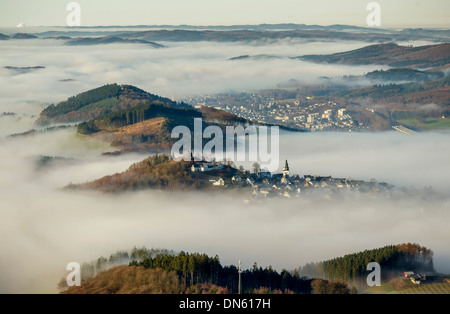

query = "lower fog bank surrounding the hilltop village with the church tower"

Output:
[[0, 126, 450, 292]]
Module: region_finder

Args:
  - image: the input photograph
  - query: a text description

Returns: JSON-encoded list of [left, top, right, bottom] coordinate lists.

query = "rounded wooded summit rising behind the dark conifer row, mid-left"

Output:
[[37, 84, 183, 125]]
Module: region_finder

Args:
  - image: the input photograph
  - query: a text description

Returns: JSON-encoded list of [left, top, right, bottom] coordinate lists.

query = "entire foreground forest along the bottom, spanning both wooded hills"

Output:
[[59, 243, 434, 294]]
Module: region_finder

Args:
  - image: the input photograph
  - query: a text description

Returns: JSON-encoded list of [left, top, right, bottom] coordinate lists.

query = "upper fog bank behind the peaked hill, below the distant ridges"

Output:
[[0, 39, 380, 103]]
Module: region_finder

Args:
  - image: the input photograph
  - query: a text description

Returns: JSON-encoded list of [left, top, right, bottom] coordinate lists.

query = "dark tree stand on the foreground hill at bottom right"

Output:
[[300, 243, 434, 281]]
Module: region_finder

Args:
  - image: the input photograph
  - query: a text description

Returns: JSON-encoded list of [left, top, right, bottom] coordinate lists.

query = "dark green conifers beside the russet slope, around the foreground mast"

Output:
[[129, 252, 311, 293]]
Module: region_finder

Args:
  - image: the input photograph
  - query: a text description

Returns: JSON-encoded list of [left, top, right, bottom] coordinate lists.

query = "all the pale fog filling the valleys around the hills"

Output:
[[0, 29, 450, 292]]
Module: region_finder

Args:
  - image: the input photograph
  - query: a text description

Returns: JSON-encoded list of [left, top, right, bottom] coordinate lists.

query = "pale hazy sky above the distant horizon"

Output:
[[0, 0, 450, 27]]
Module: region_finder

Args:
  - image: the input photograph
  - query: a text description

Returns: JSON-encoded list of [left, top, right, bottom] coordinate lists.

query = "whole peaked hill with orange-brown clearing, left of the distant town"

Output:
[[36, 84, 251, 151]]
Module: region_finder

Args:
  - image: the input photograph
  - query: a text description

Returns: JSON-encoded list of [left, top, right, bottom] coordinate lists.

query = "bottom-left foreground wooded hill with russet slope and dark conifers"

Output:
[[59, 247, 312, 294]]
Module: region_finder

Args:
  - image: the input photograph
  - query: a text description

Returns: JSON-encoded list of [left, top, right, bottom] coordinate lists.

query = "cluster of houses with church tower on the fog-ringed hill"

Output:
[[191, 160, 391, 199]]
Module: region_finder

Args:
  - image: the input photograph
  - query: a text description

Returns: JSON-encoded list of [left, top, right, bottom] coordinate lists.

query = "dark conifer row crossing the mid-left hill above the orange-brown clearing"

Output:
[[77, 101, 202, 134]]
